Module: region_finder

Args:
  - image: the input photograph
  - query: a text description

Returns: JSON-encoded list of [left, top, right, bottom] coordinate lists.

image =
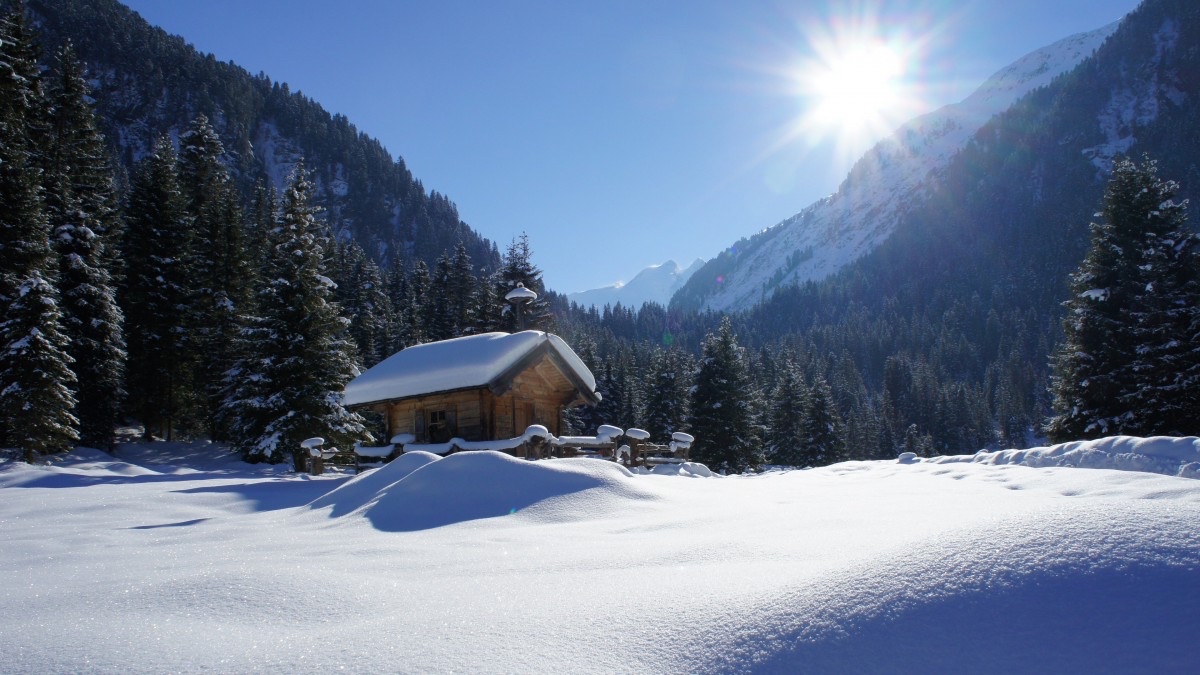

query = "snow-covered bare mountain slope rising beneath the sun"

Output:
[[674, 23, 1117, 311]]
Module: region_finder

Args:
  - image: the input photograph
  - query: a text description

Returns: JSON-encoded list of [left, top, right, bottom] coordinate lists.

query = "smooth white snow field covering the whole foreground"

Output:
[[0, 438, 1200, 673]]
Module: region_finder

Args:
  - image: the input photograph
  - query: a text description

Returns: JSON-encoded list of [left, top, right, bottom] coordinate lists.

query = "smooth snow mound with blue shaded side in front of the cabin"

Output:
[[312, 450, 655, 532]]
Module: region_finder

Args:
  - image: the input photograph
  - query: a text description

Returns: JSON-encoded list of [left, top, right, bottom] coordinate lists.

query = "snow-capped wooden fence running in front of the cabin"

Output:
[[296, 424, 695, 476]]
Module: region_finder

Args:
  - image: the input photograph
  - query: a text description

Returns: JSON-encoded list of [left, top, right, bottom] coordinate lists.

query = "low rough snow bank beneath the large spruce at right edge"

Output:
[[925, 436, 1200, 478]]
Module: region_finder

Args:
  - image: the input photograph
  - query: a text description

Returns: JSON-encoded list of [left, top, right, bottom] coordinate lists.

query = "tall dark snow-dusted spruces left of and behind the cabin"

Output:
[[0, 5, 548, 461]]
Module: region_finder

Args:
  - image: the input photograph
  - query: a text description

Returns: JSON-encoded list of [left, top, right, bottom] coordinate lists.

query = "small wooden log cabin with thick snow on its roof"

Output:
[[342, 330, 600, 443]]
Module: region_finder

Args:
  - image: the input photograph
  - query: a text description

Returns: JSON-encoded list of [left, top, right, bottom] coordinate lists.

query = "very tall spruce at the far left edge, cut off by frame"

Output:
[[0, 5, 79, 461]]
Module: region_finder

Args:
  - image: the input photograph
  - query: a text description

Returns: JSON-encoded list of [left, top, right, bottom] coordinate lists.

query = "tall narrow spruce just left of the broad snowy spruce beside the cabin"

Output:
[[179, 115, 253, 438]]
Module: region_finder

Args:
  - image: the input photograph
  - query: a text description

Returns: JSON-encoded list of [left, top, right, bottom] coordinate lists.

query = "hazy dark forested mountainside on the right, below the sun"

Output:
[[552, 0, 1200, 464]]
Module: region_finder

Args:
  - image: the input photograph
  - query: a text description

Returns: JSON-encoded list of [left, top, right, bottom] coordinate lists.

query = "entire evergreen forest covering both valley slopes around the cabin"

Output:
[[0, 0, 1200, 471]]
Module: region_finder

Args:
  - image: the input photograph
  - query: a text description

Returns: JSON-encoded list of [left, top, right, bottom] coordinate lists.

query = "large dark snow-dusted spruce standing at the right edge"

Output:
[[1048, 159, 1196, 441]]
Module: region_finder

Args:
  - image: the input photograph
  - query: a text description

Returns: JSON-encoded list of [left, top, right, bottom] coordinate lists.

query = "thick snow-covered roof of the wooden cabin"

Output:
[[342, 330, 596, 406]]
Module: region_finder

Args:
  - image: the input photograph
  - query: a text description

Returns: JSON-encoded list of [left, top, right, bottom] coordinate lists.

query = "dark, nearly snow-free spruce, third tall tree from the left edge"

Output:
[[120, 137, 198, 438]]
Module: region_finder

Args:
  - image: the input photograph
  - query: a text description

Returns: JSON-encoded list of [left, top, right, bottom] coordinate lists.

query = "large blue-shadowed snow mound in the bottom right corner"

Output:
[[696, 501, 1200, 674]]
